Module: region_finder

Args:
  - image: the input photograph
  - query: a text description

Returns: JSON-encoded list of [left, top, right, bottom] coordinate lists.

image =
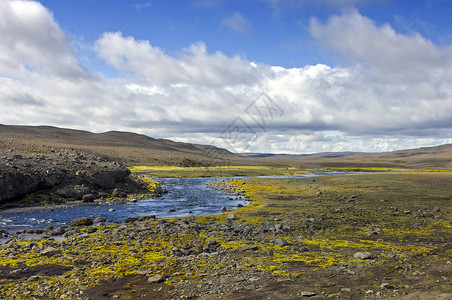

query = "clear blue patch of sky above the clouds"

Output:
[[41, 0, 452, 68]]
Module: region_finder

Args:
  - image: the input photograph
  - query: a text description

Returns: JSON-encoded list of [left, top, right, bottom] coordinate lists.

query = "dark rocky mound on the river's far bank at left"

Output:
[[0, 149, 151, 203]]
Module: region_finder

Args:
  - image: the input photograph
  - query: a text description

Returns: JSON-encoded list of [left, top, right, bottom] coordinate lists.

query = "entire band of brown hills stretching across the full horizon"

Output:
[[0, 125, 452, 169]]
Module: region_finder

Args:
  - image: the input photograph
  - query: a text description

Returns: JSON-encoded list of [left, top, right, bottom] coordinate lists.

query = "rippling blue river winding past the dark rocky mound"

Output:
[[0, 172, 338, 233]]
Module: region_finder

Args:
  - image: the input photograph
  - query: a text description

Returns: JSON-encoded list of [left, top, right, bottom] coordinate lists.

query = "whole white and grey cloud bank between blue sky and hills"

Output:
[[0, 1, 452, 153]]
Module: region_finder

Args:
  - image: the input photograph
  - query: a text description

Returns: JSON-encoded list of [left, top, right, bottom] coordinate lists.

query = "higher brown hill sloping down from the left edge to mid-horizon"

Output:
[[0, 125, 239, 166]]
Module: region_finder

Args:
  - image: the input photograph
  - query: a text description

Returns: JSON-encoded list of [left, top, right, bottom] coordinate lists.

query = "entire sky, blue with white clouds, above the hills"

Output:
[[0, 0, 452, 154]]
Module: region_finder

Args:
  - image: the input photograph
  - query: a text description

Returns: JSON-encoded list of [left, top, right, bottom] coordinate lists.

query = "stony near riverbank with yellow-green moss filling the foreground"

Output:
[[0, 172, 452, 299]]
